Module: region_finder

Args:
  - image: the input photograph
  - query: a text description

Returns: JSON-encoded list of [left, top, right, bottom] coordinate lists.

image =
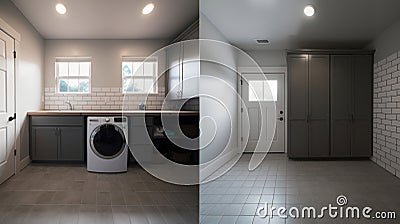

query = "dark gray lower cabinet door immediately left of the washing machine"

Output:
[[58, 127, 84, 161]]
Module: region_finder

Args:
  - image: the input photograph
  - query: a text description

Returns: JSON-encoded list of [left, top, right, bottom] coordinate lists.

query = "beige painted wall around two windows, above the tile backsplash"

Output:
[[45, 40, 169, 88]]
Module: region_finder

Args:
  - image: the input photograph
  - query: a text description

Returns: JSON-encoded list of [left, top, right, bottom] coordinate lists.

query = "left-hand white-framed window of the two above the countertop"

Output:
[[55, 58, 92, 93]]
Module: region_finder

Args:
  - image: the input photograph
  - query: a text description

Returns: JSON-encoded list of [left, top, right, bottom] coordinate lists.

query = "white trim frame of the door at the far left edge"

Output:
[[0, 18, 21, 175]]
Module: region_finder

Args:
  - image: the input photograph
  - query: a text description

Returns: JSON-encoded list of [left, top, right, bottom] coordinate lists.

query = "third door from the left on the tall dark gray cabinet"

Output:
[[331, 55, 353, 157]]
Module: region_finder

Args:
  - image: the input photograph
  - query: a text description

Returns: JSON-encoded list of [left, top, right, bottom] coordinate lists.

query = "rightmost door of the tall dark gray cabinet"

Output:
[[351, 55, 373, 157]]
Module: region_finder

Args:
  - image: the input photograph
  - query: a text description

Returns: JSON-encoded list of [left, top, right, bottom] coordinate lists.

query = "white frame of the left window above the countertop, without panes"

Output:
[[54, 57, 92, 95]]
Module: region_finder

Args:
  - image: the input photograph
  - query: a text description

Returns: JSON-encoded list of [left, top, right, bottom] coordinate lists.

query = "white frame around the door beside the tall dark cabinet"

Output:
[[237, 67, 288, 153]]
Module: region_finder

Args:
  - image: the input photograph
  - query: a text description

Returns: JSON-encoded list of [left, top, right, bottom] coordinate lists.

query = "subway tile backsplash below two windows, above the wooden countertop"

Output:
[[44, 87, 165, 110]]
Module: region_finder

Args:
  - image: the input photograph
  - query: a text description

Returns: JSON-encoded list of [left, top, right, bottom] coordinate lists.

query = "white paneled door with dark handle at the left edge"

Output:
[[0, 30, 15, 183]]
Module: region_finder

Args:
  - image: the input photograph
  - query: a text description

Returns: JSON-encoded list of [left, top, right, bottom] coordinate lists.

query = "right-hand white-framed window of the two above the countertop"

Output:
[[122, 57, 158, 93]]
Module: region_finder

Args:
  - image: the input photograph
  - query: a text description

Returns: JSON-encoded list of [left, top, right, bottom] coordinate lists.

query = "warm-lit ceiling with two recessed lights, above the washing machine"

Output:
[[12, 0, 199, 39]]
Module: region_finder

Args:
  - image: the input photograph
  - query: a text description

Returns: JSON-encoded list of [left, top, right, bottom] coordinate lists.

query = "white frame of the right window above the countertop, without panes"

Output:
[[120, 56, 159, 95]]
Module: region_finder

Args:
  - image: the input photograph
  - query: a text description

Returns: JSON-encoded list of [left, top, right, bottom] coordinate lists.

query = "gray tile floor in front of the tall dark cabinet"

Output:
[[200, 154, 400, 224]]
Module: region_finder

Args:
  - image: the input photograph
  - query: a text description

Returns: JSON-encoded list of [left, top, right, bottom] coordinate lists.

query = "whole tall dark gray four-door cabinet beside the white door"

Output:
[[287, 50, 373, 158]]
